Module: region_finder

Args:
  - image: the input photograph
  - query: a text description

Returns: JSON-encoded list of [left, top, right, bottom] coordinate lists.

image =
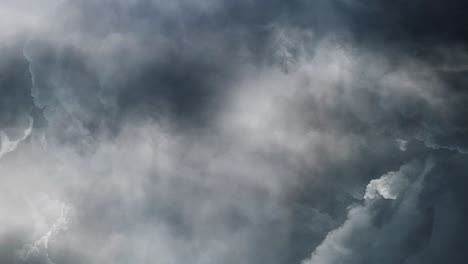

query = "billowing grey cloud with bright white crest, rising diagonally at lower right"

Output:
[[303, 161, 433, 263]]
